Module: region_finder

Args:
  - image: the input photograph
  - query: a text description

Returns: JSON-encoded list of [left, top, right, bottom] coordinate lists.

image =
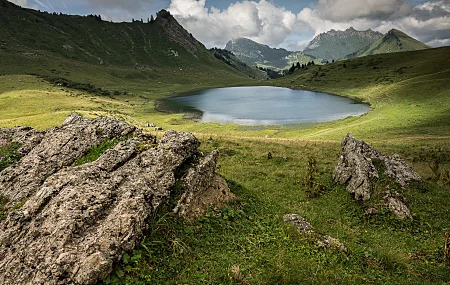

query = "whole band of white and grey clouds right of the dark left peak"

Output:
[[168, 0, 450, 50]]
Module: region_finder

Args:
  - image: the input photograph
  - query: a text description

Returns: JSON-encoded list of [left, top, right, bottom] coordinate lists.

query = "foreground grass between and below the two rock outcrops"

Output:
[[100, 138, 450, 284]]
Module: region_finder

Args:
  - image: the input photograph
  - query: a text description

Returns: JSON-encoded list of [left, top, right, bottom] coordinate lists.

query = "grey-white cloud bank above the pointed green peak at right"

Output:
[[297, 0, 450, 47]]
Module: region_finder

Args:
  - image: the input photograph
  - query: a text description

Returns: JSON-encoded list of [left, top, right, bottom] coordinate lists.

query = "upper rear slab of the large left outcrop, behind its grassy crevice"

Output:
[[0, 115, 136, 207]]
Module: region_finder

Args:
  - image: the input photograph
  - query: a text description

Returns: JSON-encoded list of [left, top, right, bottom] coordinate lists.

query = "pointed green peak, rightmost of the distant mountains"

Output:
[[358, 29, 431, 56]]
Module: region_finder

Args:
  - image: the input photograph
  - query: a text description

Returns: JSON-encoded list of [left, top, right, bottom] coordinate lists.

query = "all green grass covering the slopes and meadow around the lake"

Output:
[[0, 0, 450, 284]]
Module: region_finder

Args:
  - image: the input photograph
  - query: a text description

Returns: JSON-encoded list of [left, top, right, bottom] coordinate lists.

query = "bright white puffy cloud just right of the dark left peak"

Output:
[[168, 0, 308, 47]]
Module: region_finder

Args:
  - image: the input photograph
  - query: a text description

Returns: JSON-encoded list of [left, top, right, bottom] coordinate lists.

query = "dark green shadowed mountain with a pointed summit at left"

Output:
[[0, 0, 248, 79]]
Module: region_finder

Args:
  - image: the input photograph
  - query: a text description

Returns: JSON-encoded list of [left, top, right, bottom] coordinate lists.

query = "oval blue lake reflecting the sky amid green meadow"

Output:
[[164, 86, 370, 126]]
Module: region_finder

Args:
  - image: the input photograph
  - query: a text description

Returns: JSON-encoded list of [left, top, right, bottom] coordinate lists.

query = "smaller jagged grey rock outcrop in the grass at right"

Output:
[[333, 134, 422, 218]]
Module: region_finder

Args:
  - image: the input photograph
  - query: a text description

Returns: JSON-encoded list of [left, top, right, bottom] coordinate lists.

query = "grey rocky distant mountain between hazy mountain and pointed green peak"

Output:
[[303, 27, 383, 61]]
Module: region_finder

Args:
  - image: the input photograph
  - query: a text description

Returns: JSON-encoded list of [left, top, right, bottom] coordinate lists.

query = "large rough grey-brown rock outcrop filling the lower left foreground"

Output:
[[0, 117, 230, 285]]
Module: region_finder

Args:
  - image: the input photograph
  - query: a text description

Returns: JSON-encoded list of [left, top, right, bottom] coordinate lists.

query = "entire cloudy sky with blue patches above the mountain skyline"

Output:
[[10, 0, 450, 51]]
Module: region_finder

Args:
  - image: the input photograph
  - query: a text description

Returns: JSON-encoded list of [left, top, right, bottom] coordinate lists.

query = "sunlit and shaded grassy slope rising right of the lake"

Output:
[[268, 47, 450, 140]]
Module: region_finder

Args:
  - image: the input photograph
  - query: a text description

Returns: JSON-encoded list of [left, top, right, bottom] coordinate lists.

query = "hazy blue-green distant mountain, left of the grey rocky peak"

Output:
[[225, 38, 320, 69]]
